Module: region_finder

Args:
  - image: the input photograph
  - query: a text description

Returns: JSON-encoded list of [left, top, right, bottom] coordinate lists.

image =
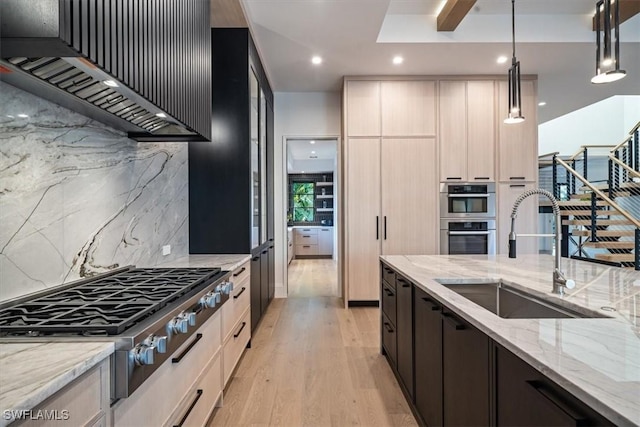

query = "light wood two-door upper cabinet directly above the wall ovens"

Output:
[[438, 80, 496, 182]]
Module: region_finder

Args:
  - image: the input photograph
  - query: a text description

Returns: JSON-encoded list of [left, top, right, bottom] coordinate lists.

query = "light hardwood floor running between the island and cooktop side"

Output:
[[209, 260, 416, 426]]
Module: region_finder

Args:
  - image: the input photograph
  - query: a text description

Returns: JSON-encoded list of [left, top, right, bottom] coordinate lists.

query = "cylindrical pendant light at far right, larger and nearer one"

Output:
[[591, 0, 627, 84]]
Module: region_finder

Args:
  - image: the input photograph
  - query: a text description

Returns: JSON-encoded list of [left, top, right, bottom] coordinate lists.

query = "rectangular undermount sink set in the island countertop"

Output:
[[435, 279, 609, 319]]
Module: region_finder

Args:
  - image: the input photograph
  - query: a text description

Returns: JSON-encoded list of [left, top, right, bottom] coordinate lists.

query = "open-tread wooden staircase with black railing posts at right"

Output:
[[540, 122, 640, 270]]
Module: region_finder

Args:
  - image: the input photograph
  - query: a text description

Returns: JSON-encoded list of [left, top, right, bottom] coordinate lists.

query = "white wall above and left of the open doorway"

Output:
[[274, 92, 341, 297]]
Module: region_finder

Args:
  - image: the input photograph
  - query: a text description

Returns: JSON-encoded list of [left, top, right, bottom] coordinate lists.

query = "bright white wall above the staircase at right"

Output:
[[538, 95, 640, 155]]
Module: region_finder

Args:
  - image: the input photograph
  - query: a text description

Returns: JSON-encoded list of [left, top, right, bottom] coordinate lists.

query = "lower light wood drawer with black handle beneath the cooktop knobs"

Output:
[[166, 353, 222, 427]]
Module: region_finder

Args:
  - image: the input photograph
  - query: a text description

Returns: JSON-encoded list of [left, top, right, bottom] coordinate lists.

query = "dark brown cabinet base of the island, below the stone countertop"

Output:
[[380, 262, 614, 427]]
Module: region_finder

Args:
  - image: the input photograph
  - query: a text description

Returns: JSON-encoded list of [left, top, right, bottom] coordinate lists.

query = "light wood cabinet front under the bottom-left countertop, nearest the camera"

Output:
[[12, 359, 110, 427]]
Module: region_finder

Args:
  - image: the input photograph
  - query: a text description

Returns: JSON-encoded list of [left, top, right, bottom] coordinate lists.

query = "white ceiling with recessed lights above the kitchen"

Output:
[[242, 0, 640, 123]]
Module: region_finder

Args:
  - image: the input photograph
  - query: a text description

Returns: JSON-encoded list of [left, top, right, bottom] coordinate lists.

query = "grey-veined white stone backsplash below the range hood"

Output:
[[0, 82, 189, 301]]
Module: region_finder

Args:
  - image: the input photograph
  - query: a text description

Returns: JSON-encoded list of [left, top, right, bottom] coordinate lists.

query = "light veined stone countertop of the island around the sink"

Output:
[[380, 255, 640, 426]]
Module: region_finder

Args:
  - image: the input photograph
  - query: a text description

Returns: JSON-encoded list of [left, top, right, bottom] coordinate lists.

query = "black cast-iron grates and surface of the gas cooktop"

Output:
[[0, 268, 222, 336]]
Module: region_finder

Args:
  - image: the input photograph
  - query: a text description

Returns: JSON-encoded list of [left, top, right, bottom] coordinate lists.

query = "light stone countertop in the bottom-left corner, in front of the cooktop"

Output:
[[0, 341, 114, 427]]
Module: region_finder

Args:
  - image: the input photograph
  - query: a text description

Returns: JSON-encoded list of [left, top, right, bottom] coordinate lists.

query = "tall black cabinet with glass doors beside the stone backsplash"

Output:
[[189, 28, 275, 330]]
